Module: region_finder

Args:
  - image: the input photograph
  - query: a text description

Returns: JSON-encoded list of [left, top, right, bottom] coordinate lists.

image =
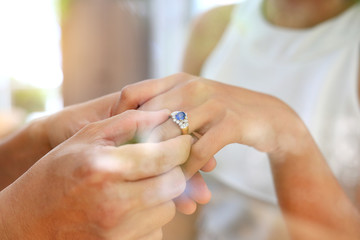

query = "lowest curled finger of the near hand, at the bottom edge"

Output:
[[108, 201, 176, 240]]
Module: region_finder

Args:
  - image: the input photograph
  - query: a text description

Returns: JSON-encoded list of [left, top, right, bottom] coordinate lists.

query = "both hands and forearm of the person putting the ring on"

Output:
[[0, 92, 210, 239]]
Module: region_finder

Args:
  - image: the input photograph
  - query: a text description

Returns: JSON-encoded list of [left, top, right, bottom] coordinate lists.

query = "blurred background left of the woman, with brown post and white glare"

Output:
[[0, 0, 240, 138]]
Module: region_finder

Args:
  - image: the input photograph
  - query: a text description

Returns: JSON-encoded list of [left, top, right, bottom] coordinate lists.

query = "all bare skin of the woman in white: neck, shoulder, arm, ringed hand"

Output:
[[114, 0, 360, 239]]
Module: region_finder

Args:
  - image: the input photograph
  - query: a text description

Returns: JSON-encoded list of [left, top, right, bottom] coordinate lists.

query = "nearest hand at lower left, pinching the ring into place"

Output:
[[0, 111, 192, 240]]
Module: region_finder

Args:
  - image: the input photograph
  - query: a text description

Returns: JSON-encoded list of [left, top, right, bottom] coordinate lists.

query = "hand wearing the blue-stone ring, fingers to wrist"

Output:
[[115, 73, 307, 177]]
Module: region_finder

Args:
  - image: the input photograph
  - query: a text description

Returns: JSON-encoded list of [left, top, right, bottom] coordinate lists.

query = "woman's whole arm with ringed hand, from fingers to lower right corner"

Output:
[[120, 74, 360, 239]]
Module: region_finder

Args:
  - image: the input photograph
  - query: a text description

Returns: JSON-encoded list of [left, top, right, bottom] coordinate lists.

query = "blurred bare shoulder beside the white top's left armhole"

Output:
[[183, 5, 235, 75]]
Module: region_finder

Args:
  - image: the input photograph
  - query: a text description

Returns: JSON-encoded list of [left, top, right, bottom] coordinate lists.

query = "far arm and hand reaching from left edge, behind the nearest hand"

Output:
[[0, 92, 127, 189]]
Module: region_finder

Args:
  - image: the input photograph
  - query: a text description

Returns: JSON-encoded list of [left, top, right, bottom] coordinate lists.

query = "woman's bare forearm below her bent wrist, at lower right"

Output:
[[270, 129, 360, 239]]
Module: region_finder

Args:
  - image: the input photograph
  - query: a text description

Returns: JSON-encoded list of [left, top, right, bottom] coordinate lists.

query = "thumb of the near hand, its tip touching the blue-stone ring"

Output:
[[81, 110, 169, 146]]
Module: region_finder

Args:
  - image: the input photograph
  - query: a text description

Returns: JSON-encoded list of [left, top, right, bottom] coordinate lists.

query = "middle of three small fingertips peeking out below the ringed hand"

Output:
[[186, 172, 211, 204]]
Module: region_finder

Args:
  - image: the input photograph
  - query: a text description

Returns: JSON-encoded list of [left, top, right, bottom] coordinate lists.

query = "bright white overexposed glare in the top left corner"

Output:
[[0, 0, 63, 88]]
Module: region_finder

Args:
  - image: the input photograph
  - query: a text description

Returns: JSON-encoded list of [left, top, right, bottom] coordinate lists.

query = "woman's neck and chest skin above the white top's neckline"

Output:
[[264, 0, 355, 28]]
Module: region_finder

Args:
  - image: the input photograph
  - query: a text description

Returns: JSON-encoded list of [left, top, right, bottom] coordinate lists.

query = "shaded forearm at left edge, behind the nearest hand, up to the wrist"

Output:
[[0, 120, 51, 189]]
